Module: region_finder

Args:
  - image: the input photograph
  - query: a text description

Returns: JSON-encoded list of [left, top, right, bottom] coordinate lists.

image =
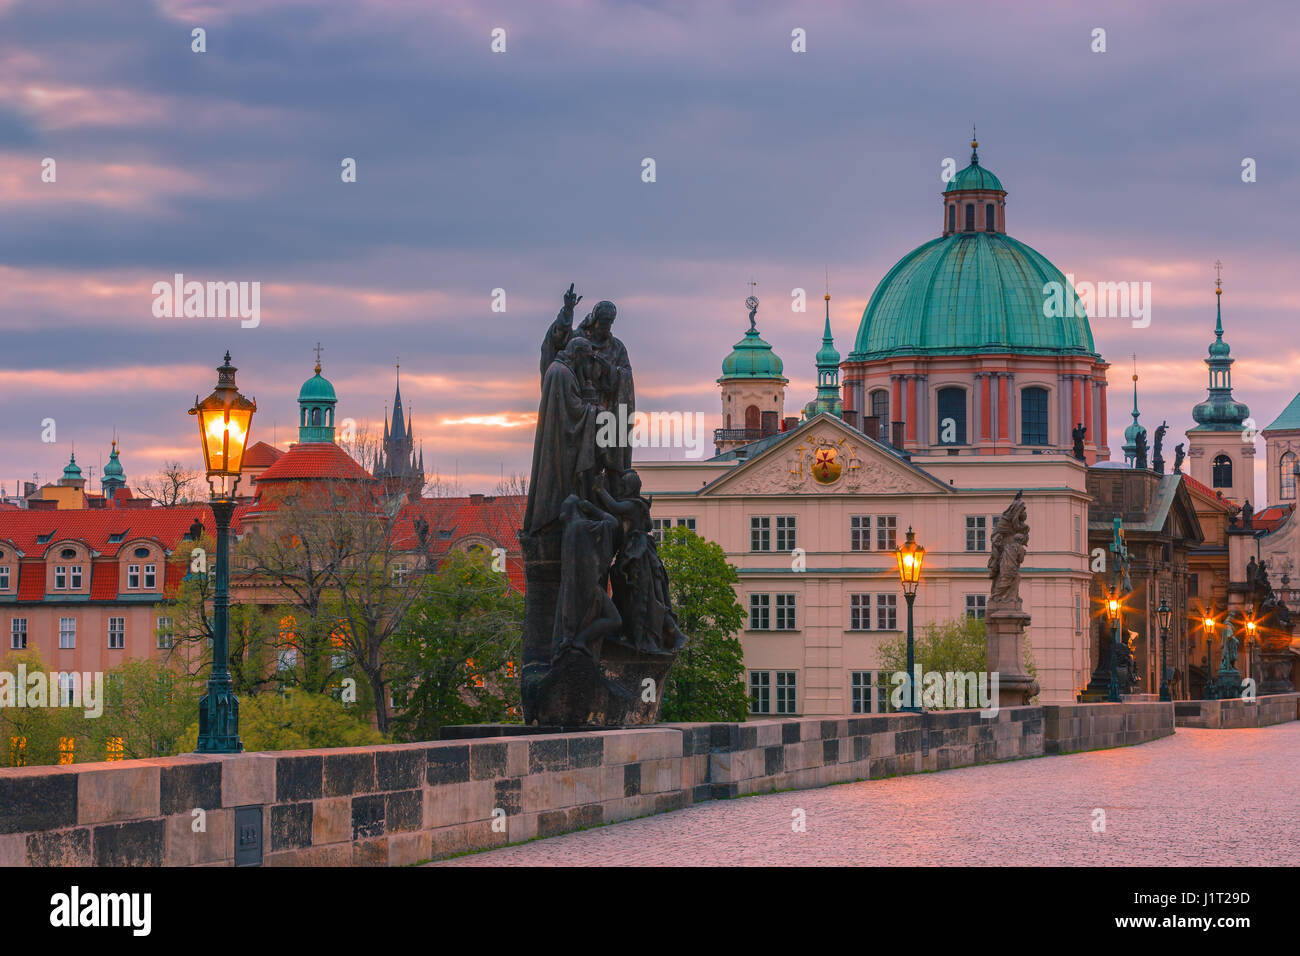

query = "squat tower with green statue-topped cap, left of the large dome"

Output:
[[714, 295, 789, 454]]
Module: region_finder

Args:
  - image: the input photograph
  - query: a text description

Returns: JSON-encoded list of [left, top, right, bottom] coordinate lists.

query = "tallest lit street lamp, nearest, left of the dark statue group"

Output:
[[190, 352, 257, 753]]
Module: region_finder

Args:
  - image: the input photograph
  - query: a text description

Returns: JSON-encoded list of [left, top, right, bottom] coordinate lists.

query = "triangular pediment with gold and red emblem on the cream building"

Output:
[[701, 414, 953, 496]]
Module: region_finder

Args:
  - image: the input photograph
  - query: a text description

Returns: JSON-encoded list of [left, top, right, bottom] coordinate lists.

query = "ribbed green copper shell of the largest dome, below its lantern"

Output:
[[849, 232, 1096, 362]]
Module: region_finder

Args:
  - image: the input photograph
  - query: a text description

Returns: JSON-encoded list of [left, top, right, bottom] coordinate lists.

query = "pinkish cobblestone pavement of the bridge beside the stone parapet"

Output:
[[433, 722, 1300, 866]]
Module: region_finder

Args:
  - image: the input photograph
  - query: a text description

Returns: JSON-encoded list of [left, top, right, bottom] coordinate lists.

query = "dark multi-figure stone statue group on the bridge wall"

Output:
[[520, 285, 686, 727]]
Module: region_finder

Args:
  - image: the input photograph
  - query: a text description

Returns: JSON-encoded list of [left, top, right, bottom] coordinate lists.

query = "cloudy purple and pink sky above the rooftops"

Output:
[[0, 0, 1300, 501]]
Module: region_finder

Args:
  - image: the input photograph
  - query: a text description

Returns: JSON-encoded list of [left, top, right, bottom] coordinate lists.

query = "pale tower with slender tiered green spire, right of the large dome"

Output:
[[1187, 263, 1255, 502]]
